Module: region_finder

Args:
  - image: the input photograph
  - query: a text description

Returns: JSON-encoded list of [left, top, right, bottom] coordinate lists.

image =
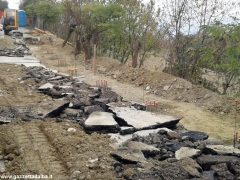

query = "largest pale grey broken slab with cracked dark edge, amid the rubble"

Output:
[[109, 106, 180, 130]]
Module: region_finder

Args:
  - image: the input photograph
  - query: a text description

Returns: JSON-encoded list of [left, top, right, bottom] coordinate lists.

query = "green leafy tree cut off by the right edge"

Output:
[[201, 24, 240, 94]]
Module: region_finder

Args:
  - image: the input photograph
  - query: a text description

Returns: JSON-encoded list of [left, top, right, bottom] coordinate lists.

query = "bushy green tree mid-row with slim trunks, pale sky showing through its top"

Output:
[[102, 0, 160, 68]]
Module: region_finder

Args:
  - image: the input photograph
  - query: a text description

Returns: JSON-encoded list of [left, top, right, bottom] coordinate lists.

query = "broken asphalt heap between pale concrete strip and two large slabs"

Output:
[[21, 67, 121, 124]]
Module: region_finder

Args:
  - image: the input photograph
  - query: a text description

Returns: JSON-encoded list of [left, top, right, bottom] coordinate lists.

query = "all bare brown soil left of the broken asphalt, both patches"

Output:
[[0, 64, 114, 180]]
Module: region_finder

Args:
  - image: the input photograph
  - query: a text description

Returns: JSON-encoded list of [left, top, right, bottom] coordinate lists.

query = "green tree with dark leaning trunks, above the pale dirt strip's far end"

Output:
[[63, 0, 121, 62]]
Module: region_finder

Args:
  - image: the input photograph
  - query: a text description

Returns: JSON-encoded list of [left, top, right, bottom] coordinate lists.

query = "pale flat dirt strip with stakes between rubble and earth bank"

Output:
[[31, 40, 240, 143]]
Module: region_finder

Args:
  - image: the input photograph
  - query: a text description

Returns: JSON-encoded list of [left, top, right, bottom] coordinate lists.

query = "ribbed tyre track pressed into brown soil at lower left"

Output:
[[12, 123, 68, 180]]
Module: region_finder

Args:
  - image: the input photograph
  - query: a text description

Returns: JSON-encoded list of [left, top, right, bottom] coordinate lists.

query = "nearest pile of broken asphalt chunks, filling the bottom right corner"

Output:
[[112, 128, 240, 180]]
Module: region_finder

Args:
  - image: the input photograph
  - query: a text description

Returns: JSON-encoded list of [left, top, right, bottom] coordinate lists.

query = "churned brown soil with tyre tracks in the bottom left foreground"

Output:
[[0, 120, 114, 180]]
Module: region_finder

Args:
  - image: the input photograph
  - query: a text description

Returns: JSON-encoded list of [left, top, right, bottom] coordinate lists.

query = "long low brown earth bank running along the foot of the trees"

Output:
[[99, 61, 238, 114]]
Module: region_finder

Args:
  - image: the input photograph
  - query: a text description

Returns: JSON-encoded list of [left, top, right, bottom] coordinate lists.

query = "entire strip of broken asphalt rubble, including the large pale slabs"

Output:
[[0, 67, 240, 179]]
